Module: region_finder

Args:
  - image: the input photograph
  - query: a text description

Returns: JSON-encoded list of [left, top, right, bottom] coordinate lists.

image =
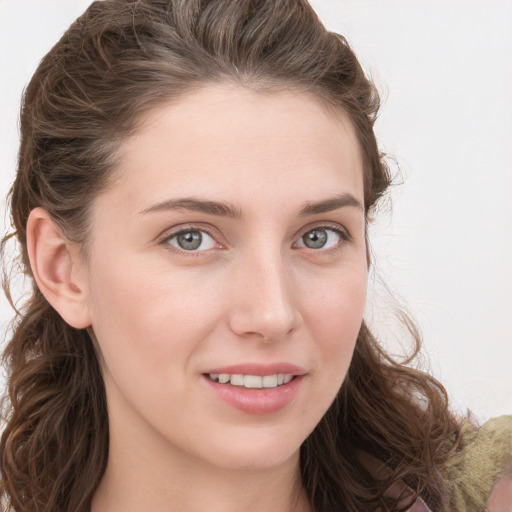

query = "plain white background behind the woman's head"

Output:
[[0, 0, 512, 421]]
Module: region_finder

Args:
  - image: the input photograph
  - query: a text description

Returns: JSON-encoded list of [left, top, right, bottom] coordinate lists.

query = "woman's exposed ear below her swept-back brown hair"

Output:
[[27, 208, 91, 329]]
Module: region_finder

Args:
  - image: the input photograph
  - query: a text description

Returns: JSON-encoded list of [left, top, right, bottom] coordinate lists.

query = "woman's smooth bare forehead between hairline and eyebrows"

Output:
[[107, 84, 363, 210]]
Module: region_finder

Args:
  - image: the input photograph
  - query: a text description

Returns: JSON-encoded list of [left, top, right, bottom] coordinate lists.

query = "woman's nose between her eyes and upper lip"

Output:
[[229, 250, 300, 341]]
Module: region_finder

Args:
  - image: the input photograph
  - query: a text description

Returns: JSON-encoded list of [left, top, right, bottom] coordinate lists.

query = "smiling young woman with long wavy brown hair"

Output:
[[0, 0, 509, 512]]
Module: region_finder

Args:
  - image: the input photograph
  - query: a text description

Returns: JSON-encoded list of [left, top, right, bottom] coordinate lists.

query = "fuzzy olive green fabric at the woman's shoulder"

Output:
[[444, 416, 512, 512]]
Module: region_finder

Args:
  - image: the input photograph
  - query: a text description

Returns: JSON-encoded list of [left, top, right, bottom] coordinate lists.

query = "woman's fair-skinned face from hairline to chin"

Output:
[[80, 85, 367, 469]]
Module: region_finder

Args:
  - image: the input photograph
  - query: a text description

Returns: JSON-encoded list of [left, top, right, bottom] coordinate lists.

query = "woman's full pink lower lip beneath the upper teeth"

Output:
[[203, 375, 304, 414]]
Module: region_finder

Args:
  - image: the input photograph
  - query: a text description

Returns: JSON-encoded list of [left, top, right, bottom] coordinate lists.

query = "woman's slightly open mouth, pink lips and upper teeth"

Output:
[[203, 363, 306, 414]]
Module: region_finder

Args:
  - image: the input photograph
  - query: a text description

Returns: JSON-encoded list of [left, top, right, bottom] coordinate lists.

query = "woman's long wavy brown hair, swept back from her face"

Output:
[[0, 0, 459, 512]]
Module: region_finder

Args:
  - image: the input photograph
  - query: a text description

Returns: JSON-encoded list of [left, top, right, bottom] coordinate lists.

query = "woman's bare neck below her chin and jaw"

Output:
[[91, 412, 311, 512]]
